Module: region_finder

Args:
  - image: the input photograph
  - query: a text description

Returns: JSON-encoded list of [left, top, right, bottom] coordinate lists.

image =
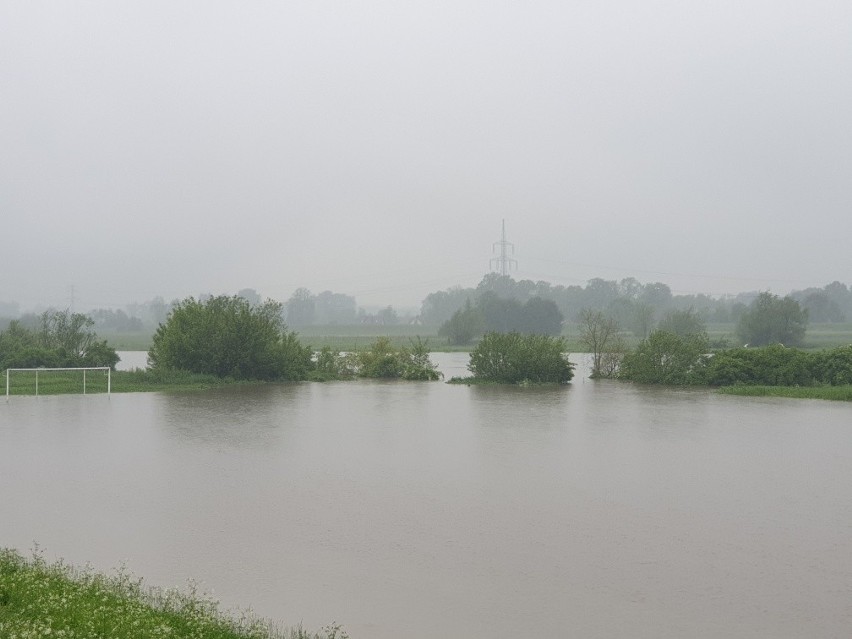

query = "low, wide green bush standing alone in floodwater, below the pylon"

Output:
[[468, 332, 574, 384]]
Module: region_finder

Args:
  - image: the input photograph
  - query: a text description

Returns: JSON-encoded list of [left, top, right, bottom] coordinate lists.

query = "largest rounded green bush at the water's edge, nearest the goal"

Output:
[[148, 295, 312, 380]]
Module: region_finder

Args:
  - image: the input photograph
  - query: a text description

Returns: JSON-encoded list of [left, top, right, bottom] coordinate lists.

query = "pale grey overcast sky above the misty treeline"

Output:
[[0, 0, 852, 310]]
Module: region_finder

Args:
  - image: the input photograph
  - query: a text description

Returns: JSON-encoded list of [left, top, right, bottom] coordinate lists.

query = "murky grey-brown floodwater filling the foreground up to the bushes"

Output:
[[0, 354, 852, 639]]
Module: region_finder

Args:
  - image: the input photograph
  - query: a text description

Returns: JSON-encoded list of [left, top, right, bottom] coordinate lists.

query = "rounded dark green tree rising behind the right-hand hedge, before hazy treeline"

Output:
[[737, 292, 808, 346]]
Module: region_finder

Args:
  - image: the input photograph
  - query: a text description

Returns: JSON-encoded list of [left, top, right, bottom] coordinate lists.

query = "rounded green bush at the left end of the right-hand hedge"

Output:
[[618, 330, 709, 386]]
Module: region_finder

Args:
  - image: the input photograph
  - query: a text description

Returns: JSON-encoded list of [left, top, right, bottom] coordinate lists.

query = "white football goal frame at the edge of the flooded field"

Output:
[[6, 366, 112, 401]]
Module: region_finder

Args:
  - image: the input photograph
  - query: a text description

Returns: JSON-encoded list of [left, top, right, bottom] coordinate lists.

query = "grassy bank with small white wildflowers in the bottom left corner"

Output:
[[0, 549, 347, 639]]
